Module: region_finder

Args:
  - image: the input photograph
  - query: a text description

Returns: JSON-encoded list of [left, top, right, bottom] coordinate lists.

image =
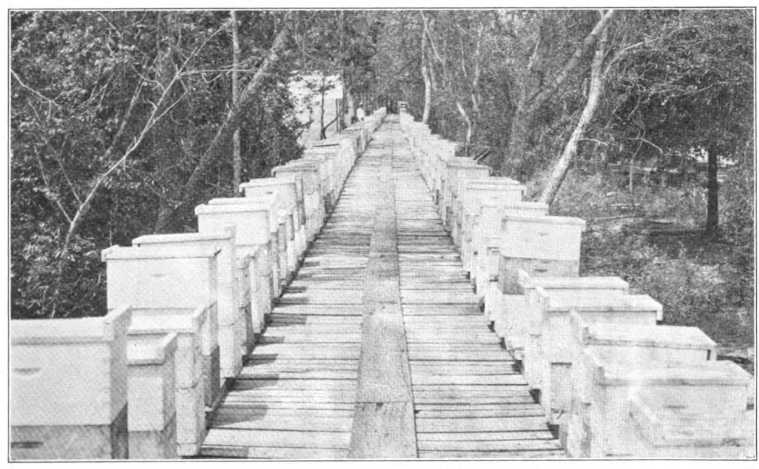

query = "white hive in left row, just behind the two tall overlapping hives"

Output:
[[195, 197, 280, 298]]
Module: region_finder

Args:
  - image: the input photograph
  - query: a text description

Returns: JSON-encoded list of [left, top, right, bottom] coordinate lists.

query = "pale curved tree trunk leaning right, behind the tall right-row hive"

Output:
[[540, 20, 608, 206]]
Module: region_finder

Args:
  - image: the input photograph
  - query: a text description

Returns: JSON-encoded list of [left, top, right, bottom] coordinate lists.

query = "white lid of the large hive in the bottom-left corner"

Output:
[[10, 307, 131, 345]]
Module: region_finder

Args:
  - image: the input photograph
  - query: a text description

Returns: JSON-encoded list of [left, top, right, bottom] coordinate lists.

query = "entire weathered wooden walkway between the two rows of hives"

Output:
[[201, 116, 564, 459]]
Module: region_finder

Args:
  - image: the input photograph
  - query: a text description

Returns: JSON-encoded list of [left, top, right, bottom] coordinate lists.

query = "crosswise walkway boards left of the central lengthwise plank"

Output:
[[201, 135, 374, 459]]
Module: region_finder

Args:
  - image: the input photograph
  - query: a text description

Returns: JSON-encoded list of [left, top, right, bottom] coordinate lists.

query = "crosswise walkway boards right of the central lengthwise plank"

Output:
[[394, 130, 564, 459]]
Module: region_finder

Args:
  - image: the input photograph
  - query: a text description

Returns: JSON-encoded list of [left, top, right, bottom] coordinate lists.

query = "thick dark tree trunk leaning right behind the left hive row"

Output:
[[155, 18, 290, 233]]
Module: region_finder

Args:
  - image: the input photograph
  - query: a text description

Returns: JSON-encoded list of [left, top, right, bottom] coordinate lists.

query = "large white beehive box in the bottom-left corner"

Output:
[[9, 308, 130, 460]]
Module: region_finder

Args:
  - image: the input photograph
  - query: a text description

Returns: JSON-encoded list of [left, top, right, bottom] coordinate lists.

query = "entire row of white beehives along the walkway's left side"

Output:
[[10, 109, 385, 459]]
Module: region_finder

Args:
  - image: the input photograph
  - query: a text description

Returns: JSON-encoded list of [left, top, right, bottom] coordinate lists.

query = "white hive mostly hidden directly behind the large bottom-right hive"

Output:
[[561, 311, 716, 454]]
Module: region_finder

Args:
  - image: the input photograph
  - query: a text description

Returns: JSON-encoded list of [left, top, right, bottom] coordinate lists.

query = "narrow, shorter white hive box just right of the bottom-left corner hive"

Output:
[[127, 333, 177, 459]]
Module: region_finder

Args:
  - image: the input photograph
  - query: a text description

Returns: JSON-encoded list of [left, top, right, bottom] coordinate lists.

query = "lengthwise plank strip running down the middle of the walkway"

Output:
[[348, 138, 416, 458]]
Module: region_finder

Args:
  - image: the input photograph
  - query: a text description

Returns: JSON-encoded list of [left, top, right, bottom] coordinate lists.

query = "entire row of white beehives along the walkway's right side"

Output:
[[401, 112, 755, 458]]
